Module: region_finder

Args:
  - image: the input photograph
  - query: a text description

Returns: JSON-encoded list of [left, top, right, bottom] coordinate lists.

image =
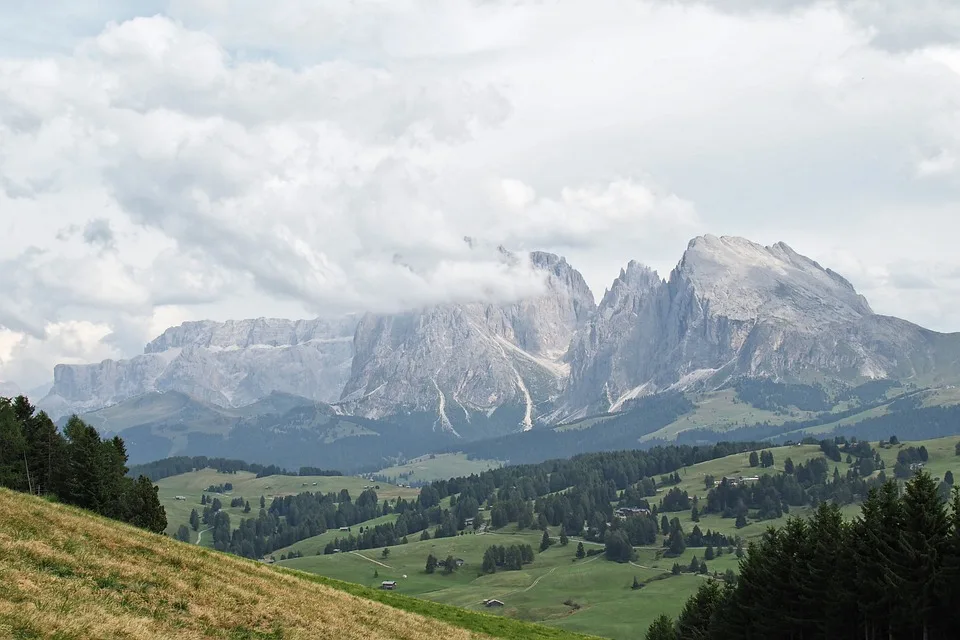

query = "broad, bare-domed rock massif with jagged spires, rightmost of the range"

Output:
[[564, 236, 960, 416]]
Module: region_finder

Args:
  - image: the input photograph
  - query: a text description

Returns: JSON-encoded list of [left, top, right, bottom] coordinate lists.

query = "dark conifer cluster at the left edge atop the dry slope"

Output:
[[0, 396, 167, 533]]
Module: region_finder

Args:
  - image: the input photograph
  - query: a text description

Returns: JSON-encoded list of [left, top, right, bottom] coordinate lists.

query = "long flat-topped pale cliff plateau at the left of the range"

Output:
[[39, 317, 356, 416]]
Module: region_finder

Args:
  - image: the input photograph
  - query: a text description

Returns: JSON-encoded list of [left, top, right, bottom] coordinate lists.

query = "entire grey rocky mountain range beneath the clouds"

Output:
[[28, 235, 960, 462]]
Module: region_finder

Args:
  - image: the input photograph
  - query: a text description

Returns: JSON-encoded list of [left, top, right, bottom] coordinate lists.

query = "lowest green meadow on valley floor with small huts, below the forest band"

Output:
[[280, 526, 712, 638]]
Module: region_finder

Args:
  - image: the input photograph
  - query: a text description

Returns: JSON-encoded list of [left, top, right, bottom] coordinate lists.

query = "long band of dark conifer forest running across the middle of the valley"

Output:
[[207, 443, 772, 558]]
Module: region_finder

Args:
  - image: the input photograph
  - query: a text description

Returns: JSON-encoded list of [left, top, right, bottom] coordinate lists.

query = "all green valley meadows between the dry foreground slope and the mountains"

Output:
[[146, 437, 960, 639]]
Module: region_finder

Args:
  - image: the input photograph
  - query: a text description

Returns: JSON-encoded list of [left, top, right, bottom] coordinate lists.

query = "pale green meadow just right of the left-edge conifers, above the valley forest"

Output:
[[157, 469, 419, 545]]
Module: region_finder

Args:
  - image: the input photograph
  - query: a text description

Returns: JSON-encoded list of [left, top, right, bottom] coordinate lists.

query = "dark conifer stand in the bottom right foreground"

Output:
[[646, 471, 960, 640]]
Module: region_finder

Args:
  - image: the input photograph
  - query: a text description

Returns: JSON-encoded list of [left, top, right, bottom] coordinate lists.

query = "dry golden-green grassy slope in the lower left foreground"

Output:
[[0, 489, 582, 640]]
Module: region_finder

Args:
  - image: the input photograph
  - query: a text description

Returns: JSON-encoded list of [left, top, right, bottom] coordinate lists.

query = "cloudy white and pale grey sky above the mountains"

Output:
[[0, 0, 960, 390]]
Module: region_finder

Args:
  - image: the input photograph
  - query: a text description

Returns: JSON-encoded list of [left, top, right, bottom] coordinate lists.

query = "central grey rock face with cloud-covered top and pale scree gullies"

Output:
[[341, 253, 595, 437]]
